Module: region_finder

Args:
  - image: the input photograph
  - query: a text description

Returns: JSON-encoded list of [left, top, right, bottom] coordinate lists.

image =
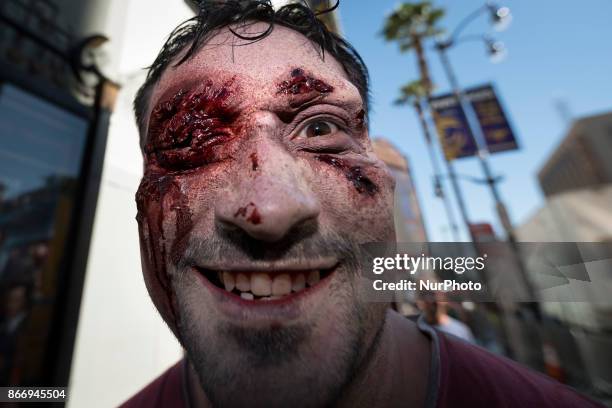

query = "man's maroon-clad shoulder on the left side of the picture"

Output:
[[120, 360, 185, 408]]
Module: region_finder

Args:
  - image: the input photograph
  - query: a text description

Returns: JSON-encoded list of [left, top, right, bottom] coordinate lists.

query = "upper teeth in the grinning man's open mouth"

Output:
[[219, 270, 321, 300]]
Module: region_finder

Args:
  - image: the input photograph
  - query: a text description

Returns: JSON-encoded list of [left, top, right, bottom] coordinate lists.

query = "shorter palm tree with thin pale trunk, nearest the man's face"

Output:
[[394, 80, 459, 241]]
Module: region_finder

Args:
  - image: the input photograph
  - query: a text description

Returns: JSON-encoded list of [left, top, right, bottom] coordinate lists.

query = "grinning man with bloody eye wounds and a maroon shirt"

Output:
[[124, 1, 604, 407]]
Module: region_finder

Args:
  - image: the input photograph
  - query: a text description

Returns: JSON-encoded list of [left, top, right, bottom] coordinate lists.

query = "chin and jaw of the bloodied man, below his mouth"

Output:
[[170, 268, 384, 407]]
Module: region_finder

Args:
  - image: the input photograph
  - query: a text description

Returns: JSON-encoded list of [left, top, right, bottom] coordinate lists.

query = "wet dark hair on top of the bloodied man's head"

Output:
[[134, 0, 369, 139]]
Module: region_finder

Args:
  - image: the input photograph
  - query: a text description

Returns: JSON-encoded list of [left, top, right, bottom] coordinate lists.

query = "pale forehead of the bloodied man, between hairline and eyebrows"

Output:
[[147, 23, 358, 116]]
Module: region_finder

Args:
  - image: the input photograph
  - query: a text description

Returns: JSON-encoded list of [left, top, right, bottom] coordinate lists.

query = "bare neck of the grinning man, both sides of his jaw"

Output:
[[187, 310, 432, 408]]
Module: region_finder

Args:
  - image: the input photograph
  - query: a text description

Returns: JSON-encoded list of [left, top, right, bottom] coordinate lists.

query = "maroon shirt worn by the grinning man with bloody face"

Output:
[[121, 326, 603, 408]]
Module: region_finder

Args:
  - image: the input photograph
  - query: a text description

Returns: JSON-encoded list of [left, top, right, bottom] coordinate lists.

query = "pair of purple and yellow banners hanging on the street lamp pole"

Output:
[[430, 84, 518, 160]]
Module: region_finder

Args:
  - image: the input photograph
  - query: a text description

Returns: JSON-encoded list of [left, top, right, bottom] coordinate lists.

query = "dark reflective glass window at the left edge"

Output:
[[0, 84, 88, 386]]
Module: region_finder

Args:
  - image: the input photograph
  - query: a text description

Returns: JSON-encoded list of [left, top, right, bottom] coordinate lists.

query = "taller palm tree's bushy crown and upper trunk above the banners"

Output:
[[382, 1, 444, 97]]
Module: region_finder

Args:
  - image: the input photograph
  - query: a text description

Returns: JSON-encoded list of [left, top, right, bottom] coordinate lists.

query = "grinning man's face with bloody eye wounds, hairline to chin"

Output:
[[137, 24, 395, 406]]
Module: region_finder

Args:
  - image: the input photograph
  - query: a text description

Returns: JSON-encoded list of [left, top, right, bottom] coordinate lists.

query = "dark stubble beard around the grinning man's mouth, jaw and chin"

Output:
[[173, 266, 386, 408]]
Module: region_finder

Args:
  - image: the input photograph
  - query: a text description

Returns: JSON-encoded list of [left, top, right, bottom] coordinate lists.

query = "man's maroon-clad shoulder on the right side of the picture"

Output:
[[437, 333, 602, 408]]
